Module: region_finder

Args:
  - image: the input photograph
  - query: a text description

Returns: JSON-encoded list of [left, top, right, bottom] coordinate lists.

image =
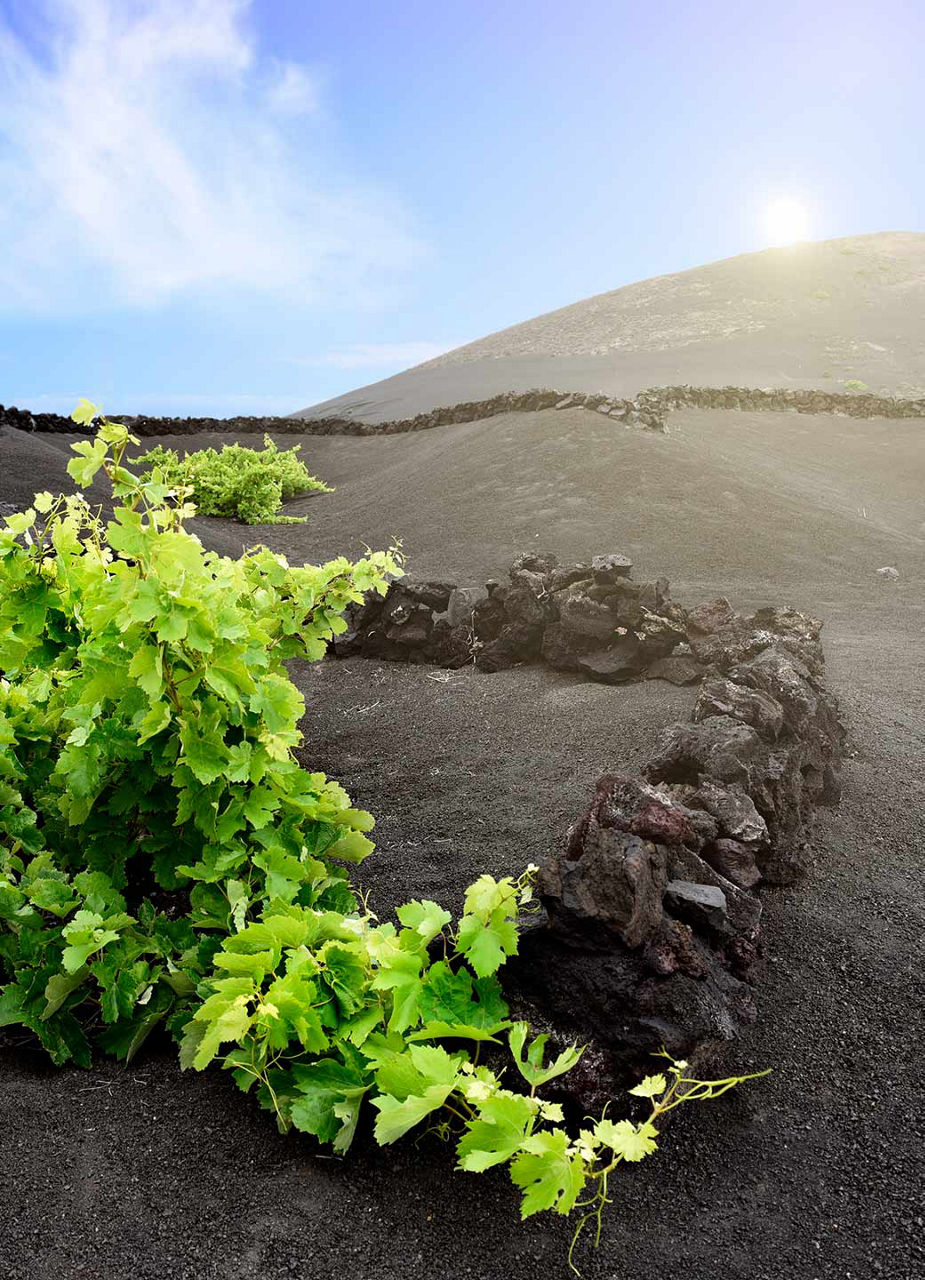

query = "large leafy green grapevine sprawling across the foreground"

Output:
[[0, 402, 767, 1262]]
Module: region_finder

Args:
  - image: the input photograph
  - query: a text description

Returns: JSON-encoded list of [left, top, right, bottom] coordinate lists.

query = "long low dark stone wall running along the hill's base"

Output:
[[7, 387, 925, 438]]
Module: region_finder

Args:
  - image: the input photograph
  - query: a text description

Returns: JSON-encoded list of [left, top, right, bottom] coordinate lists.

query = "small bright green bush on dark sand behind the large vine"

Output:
[[133, 435, 331, 525]]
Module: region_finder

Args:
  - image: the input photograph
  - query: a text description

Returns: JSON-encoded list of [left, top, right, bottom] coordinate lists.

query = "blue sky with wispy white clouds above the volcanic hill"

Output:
[[0, 0, 925, 415]]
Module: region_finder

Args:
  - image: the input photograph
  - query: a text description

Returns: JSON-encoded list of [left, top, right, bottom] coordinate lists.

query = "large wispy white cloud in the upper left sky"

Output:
[[0, 0, 420, 311]]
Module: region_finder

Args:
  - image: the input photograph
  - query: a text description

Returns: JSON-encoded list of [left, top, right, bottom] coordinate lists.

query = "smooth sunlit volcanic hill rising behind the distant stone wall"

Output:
[[298, 232, 925, 422]]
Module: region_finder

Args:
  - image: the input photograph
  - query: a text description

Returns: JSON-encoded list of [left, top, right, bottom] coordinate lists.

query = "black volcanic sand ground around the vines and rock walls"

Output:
[[0, 411, 925, 1280]]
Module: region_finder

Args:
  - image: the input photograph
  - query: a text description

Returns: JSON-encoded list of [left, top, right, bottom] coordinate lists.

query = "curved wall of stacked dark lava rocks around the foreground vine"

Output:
[[333, 554, 844, 1107]]
